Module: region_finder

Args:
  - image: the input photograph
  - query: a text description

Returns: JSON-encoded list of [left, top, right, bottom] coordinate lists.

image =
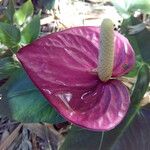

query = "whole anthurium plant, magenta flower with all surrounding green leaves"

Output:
[[0, 0, 150, 150]]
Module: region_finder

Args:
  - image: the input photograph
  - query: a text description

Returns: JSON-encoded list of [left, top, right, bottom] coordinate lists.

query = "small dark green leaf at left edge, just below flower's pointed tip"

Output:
[[0, 57, 19, 80]]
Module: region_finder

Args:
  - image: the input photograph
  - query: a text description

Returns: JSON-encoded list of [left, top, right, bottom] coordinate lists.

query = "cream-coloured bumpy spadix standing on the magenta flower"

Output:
[[97, 19, 114, 82]]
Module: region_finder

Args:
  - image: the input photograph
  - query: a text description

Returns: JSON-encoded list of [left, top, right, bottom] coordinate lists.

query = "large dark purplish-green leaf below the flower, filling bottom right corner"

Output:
[[60, 109, 150, 150]]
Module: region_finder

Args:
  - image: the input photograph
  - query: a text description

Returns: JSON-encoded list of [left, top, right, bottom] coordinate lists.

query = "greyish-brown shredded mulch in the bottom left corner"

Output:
[[0, 117, 66, 150]]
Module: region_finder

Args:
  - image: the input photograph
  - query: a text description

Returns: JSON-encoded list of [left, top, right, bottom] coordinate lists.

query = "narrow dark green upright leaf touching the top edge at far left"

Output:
[[4, 0, 15, 24]]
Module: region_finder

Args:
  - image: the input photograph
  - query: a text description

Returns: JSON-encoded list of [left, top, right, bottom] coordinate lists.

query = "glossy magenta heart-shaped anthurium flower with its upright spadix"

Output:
[[17, 19, 135, 131]]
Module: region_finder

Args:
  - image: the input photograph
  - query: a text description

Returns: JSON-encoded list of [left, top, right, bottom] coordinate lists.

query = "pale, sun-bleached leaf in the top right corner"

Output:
[[112, 0, 150, 19]]
